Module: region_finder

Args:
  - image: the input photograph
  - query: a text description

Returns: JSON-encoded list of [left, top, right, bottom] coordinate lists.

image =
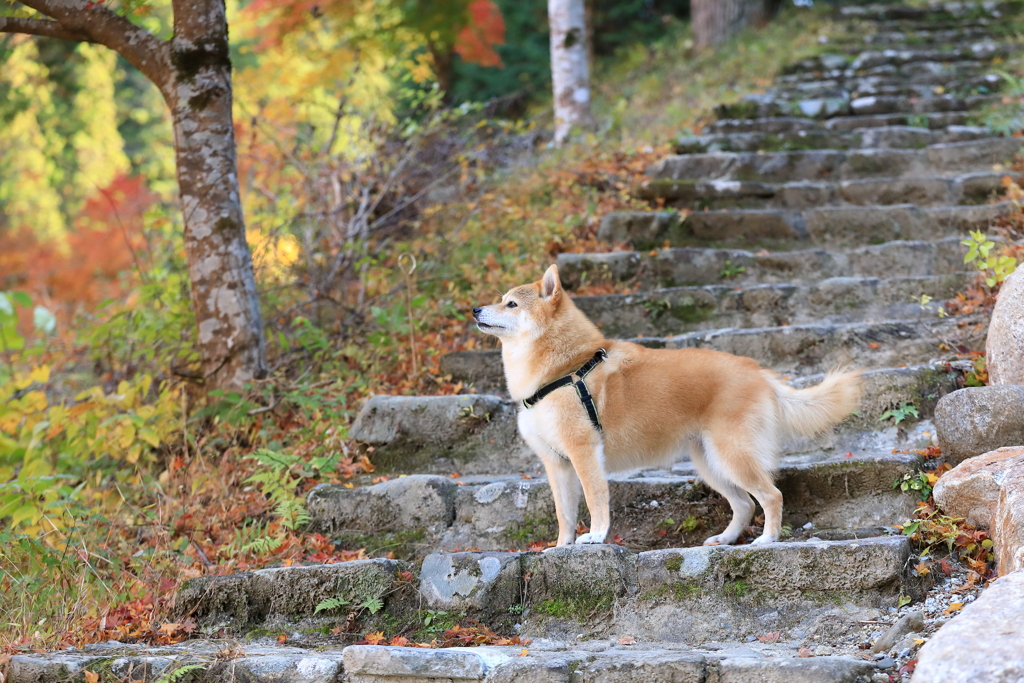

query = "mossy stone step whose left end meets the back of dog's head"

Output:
[[575, 272, 976, 338]]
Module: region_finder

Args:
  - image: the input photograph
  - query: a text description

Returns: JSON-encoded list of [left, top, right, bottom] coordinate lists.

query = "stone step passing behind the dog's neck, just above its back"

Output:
[[441, 316, 987, 391]]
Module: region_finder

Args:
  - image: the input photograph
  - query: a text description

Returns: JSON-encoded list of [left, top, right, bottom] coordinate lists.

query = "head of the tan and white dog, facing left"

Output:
[[473, 265, 565, 340]]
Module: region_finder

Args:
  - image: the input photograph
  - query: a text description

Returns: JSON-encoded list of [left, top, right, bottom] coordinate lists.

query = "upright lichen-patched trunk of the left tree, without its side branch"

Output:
[[164, 0, 266, 389]]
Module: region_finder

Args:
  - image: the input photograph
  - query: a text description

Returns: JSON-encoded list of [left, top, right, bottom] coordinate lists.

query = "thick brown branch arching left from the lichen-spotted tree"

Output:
[[7, 0, 174, 97]]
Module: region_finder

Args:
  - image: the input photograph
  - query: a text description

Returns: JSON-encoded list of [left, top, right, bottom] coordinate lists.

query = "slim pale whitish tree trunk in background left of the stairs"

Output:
[[548, 0, 591, 144]]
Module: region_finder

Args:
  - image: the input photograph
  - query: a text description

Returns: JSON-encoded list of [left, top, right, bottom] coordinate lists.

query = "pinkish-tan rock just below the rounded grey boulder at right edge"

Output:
[[933, 446, 1024, 529]]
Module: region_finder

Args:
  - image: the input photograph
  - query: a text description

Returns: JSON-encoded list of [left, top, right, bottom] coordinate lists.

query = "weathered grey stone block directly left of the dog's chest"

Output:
[[351, 395, 538, 474]]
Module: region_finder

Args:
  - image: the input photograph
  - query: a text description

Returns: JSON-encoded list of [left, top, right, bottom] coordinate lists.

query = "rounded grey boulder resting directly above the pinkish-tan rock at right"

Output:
[[935, 385, 1024, 465]]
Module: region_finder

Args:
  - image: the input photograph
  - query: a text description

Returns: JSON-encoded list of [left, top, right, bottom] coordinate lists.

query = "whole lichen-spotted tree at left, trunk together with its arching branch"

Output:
[[0, 0, 266, 389]]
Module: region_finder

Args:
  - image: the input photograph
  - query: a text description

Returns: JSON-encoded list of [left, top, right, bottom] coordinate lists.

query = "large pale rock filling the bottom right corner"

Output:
[[911, 570, 1024, 683]]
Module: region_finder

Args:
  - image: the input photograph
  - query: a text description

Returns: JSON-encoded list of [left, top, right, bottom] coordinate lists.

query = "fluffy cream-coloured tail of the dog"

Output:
[[766, 371, 861, 436]]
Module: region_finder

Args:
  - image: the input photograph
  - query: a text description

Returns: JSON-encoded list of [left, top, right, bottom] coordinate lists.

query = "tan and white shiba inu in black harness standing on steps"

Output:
[[473, 265, 860, 546]]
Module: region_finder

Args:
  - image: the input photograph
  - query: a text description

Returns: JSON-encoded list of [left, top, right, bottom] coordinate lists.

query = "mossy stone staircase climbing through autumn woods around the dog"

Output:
[[8, 2, 1021, 683]]
